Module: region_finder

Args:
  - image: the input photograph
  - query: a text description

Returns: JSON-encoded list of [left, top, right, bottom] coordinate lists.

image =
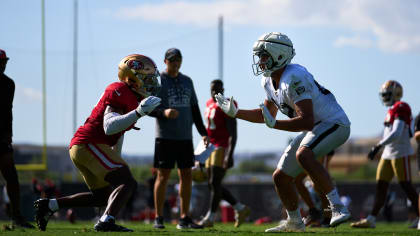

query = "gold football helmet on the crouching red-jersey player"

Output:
[[118, 54, 160, 98]]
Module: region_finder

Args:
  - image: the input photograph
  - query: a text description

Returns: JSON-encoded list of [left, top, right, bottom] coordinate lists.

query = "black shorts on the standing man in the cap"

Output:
[[153, 138, 194, 169]]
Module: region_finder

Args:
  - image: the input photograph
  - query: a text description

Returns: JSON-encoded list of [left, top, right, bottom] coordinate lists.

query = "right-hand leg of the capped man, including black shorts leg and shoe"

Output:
[[176, 140, 203, 229]]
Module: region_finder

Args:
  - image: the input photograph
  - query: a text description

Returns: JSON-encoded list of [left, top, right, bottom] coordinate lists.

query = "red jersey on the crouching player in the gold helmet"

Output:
[[70, 82, 138, 148]]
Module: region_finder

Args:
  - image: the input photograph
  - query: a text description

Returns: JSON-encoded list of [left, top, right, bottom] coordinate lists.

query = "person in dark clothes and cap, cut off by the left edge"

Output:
[[0, 49, 34, 229]]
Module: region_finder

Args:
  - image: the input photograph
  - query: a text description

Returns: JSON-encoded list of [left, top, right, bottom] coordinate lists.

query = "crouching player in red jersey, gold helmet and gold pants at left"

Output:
[[34, 54, 160, 232]]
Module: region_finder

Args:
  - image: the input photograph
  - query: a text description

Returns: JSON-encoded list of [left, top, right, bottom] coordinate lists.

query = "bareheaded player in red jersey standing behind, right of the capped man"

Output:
[[200, 80, 250, 227]]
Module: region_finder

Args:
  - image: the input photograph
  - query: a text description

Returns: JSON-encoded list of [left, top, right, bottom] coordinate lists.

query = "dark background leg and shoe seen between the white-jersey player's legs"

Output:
[[295, 172, 321, 226]]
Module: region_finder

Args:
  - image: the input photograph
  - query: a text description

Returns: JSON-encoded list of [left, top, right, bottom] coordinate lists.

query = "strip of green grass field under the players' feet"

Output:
[[0, 221, 420, 236]]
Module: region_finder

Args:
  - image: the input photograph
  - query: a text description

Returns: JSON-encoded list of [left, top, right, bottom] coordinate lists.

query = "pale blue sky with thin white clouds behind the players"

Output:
[[0, 0, 420, 155]]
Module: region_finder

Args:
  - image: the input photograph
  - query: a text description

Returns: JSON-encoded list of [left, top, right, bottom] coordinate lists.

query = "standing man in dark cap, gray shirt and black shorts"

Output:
[[151, 48, 208, 229]]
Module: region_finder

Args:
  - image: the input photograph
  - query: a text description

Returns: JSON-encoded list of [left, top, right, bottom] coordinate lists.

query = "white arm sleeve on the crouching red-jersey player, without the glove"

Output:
[[103, 110, 140, 135]]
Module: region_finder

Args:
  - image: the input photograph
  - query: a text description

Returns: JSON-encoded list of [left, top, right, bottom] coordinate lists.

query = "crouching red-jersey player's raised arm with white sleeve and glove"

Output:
[[103, 96, 161, 135]]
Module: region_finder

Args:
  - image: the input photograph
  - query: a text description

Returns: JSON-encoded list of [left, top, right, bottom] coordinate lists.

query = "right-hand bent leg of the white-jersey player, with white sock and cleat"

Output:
[[296, 122, 351, 226]]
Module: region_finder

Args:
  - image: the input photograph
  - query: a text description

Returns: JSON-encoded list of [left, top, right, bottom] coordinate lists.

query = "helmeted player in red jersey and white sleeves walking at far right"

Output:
[[351, 80, 418, 228]]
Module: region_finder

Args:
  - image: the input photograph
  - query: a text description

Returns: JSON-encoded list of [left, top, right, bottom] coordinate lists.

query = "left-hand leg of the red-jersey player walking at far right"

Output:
[[350, 158, 394, 228]]
